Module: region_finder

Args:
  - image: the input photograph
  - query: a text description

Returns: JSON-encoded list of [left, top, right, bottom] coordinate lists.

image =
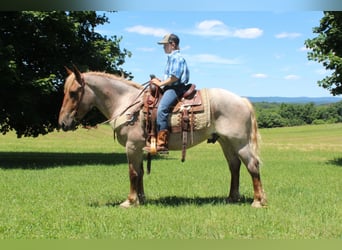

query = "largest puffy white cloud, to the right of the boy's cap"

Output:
[[191, 20, 263, 39]]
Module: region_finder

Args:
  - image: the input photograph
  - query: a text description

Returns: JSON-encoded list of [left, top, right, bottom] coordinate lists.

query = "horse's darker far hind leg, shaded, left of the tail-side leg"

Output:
[[219, 140, 241, 203]]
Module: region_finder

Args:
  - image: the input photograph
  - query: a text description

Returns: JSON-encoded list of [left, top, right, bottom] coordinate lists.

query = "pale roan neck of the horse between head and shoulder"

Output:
[[88, 76, 140, 119]]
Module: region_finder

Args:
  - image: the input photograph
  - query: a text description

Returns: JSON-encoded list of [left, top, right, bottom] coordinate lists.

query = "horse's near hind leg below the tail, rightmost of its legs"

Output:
[[239, 145, 267, 207]]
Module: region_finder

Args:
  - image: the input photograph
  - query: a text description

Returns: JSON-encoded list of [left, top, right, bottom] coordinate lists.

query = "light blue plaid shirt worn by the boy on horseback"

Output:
[[164, 50, 190, 86]]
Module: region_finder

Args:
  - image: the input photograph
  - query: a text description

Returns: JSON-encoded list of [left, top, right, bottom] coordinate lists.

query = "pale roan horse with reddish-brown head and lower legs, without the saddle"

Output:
[[58, 66, 267, 208]]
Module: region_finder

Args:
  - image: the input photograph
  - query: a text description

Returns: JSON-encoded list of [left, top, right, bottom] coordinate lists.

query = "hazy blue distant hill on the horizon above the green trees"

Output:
[[247, 96, 342, 104]]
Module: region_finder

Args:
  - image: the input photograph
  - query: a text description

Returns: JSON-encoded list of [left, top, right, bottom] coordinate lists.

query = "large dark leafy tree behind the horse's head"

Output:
[[0, 11, 132, 137]]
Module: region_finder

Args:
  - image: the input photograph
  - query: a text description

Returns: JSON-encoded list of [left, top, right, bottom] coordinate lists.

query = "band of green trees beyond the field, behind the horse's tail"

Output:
[[253, 102, 342, 128]]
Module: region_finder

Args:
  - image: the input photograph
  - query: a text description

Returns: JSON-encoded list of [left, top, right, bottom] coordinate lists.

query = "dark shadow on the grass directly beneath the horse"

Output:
[[97, 196, 253, 207]]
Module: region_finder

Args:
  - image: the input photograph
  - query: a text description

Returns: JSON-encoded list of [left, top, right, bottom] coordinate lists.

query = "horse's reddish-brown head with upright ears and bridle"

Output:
[[58, 66, 91, 131]]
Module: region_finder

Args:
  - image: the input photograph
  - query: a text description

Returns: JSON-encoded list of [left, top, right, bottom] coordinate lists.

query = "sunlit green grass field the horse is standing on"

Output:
[[0, 124, 342, 239]]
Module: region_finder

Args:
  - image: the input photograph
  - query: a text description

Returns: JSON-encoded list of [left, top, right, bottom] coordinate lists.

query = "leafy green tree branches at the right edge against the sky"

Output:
[[305, 11, 342, 96]]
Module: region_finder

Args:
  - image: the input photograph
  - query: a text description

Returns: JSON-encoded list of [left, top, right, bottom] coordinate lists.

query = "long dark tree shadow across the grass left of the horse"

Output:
[[0, 152, 127, 169]]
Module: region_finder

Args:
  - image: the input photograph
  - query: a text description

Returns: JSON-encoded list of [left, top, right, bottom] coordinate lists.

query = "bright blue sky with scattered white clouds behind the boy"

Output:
[[97, 10, 330, 97]]
